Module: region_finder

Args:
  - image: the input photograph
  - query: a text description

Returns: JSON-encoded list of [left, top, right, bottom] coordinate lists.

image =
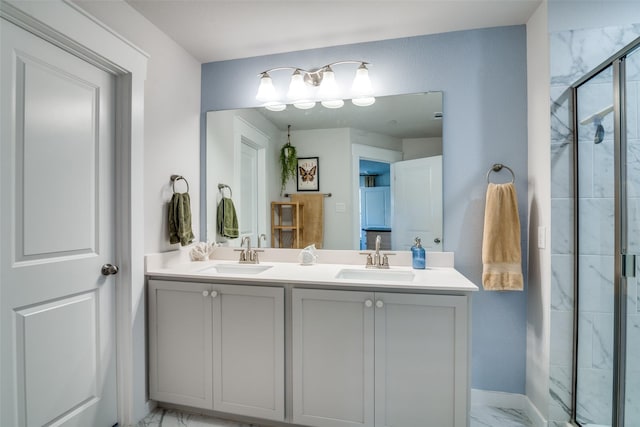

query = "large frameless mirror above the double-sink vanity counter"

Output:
[[202, 92, 444, 251]]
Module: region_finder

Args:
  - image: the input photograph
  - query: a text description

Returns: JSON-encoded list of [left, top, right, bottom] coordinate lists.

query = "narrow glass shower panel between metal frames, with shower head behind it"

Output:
[[575, 66, 616, 426]]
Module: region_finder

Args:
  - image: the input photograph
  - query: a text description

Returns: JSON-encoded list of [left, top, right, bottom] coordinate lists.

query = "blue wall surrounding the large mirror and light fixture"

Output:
[[202, 26, 527, 393]]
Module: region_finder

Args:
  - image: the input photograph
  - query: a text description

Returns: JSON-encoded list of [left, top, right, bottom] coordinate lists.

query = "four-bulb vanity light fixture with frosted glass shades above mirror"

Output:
[[256, 60, 376, 111]]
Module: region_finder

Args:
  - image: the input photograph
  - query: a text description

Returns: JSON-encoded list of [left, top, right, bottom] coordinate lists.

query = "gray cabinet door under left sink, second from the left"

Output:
[[211, 285, 284, 420]]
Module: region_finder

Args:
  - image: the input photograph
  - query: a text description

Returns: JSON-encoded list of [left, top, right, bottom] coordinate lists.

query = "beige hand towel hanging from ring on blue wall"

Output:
[[482, 183, 523, 291]]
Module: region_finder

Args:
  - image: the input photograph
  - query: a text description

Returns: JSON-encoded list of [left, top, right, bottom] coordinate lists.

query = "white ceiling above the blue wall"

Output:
[[126, 0, 542, 63]]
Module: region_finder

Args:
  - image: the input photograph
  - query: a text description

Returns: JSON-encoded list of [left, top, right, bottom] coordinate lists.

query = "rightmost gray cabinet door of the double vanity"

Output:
[[375, 293, 469, 427]]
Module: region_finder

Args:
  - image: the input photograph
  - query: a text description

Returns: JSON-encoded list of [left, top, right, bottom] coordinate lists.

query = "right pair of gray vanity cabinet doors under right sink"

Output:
[[292, 289, 469, 427]]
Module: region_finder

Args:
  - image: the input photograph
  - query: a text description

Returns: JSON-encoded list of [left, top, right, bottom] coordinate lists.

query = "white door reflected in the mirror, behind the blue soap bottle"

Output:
[[391, 156, 442, 251]]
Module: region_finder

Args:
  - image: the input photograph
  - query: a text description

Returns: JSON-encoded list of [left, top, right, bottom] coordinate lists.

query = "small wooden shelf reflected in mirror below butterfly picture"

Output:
[[271, 202, 304, 248]]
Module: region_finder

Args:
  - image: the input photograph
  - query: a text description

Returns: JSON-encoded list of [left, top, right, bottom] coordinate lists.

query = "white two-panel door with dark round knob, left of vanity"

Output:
[[0, 20, 117, 427]]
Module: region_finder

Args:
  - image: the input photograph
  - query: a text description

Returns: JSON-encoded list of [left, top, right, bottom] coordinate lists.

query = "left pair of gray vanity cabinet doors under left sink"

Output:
[[148, 280, 285, 421]]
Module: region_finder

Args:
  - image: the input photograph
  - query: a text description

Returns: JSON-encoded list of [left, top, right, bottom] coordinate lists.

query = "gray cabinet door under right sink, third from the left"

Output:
[[292, 289, 374, 427]]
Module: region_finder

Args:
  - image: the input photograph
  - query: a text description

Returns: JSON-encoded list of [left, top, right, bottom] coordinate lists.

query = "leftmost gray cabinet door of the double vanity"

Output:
[[149, 280, 213, 409]]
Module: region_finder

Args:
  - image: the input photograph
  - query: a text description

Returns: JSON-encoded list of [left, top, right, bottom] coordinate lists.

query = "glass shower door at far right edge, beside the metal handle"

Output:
[[622, 44, 640, 426]]
